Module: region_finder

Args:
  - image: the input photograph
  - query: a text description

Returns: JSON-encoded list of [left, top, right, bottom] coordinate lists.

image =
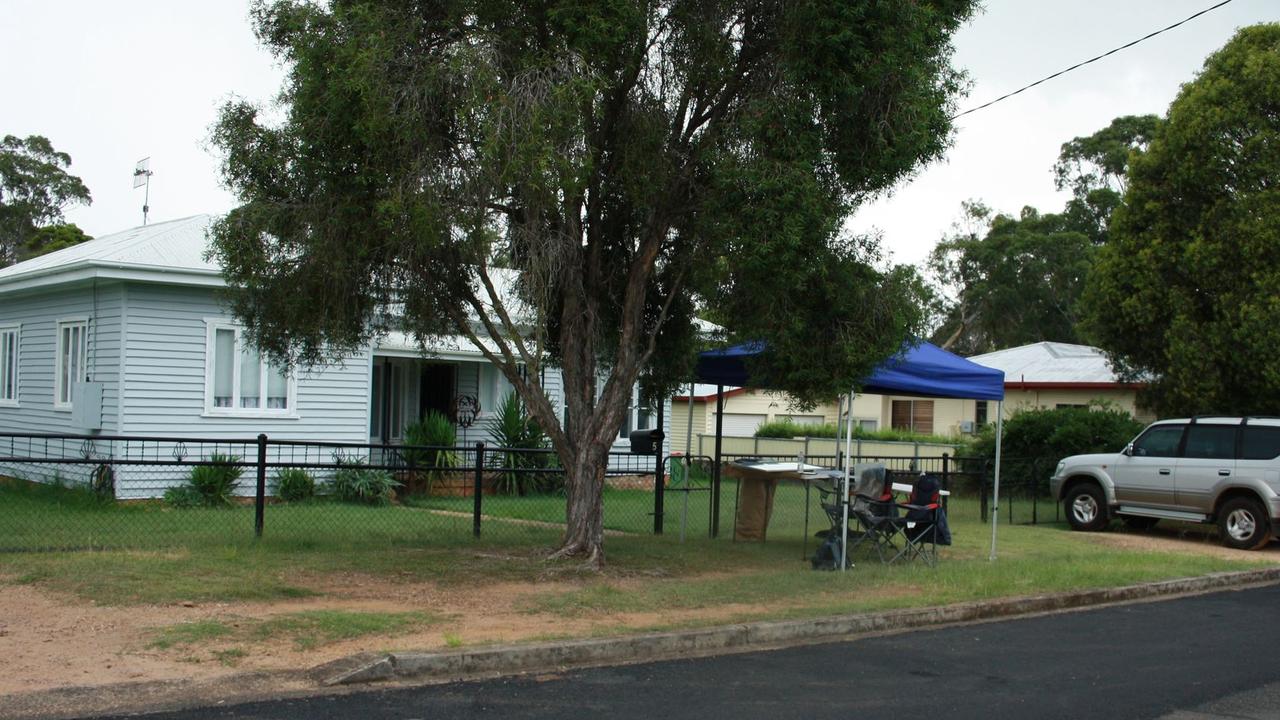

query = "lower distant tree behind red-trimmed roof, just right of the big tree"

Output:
[[928, 201, 1094, 355]]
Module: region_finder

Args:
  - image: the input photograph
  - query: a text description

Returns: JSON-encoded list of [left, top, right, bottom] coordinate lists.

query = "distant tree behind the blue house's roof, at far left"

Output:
[[0, 135, 92, 268]]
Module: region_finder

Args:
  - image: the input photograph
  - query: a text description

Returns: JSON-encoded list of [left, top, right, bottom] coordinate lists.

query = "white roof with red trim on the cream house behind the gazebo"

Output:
[[969, 342, 1128, 387]]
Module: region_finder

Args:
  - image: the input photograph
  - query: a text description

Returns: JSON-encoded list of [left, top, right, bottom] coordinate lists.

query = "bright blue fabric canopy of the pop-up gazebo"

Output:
[[696, 341, 1005, 400]]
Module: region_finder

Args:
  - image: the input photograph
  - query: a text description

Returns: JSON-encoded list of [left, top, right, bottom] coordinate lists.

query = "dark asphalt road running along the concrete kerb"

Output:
[[94, 587, 1280, 720]]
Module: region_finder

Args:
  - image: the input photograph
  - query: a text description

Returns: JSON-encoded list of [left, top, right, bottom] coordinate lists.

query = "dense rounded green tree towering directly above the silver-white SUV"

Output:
[[1085, 24, 1280, 414]]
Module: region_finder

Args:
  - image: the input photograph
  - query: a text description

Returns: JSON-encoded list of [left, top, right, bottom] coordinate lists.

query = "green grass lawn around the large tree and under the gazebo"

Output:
[[0, 483, 1261, 622]]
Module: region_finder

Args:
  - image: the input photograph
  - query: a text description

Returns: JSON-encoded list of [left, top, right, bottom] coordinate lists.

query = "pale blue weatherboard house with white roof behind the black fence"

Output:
[[0, 215, 671, 497]]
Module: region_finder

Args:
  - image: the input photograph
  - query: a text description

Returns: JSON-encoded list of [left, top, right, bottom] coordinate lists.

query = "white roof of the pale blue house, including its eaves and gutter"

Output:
[[0, 215, 224, 292]]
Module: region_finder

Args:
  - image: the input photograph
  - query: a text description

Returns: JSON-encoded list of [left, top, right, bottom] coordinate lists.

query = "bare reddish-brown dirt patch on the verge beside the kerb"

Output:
[[0, 573, 771, 696]]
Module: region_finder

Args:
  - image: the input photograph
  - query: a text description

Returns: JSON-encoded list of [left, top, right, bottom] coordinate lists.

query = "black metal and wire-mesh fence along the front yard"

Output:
[[0, 433, 1056, 551]]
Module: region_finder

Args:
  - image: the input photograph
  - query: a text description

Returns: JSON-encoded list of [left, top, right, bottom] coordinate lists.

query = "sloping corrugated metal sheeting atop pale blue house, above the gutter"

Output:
[[0, 215, 219, 283]]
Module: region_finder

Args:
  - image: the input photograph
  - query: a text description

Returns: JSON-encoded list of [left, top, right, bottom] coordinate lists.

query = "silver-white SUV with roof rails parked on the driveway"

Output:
[[1050, 416, 1280, 550]]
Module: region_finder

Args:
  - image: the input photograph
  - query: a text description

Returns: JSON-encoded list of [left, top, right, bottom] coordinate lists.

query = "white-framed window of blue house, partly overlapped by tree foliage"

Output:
[[205, 323, 294, 415]]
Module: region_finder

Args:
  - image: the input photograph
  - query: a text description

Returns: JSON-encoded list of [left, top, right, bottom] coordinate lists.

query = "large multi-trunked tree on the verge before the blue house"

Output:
[[212, 0, 972, 562]]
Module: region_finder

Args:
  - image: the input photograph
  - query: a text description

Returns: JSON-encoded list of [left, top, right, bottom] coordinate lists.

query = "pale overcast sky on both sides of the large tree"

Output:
[[0, 0, 1280, 263]]
